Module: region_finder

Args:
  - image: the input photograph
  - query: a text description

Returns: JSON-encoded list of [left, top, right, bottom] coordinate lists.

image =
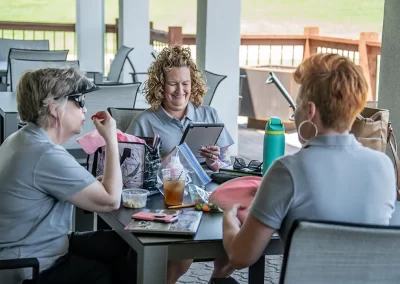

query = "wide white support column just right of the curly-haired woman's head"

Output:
[[196, 0, 241, 155]]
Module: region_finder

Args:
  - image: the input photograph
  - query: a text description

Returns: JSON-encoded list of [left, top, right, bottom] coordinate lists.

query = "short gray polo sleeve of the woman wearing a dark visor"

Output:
[[33, 146, 96, 201]]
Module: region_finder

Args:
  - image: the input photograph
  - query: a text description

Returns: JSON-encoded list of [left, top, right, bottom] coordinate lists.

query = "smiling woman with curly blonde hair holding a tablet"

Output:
[[127, 45, 234, 171]]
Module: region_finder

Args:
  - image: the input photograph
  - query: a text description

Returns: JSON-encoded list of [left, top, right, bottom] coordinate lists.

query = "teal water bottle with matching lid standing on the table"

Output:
[[263, 116, 285, 175]]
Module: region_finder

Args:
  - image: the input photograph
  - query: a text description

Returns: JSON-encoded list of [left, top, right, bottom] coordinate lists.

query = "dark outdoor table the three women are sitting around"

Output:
[[97, 182, 283, 284]]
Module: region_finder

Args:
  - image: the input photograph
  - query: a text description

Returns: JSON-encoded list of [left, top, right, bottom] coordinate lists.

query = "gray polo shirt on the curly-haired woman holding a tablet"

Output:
[[126, 102, 234, 157]]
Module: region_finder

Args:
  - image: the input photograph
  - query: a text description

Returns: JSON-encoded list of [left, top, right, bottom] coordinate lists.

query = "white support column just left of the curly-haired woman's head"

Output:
[[118, 0, 151, 83]]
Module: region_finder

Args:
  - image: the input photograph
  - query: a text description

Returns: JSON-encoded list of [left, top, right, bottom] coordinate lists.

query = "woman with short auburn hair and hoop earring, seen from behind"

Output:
[[223, 54, 396, 269]]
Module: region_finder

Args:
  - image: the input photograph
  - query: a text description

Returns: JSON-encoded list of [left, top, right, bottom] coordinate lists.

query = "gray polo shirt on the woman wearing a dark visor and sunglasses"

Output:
[[0, 123, 95, 283]]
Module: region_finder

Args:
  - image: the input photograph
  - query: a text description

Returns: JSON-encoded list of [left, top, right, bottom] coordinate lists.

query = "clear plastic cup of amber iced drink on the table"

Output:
[[161, 169, 186, 205]]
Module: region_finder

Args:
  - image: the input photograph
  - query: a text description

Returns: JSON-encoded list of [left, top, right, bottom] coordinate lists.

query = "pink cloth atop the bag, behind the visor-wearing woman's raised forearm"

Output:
[[76, 129, 146, 155]]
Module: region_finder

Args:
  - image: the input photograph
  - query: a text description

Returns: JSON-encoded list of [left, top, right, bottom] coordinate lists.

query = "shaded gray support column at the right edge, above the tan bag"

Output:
[[378, 0, 400, 137]]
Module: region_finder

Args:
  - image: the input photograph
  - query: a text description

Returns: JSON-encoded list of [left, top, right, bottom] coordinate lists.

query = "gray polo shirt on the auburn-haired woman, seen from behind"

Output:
[[250, 134, 396, 240]]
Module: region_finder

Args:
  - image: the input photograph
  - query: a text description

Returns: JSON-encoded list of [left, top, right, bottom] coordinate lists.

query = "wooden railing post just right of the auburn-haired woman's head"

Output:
[[358, 32, 379, 101]]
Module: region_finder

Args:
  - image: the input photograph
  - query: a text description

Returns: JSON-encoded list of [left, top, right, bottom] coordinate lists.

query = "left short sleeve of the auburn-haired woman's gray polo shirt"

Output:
[[249, 160, 294, 230]]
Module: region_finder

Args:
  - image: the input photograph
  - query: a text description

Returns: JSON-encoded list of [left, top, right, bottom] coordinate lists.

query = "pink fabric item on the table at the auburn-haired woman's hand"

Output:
[[209, 176, 262, 223]]
